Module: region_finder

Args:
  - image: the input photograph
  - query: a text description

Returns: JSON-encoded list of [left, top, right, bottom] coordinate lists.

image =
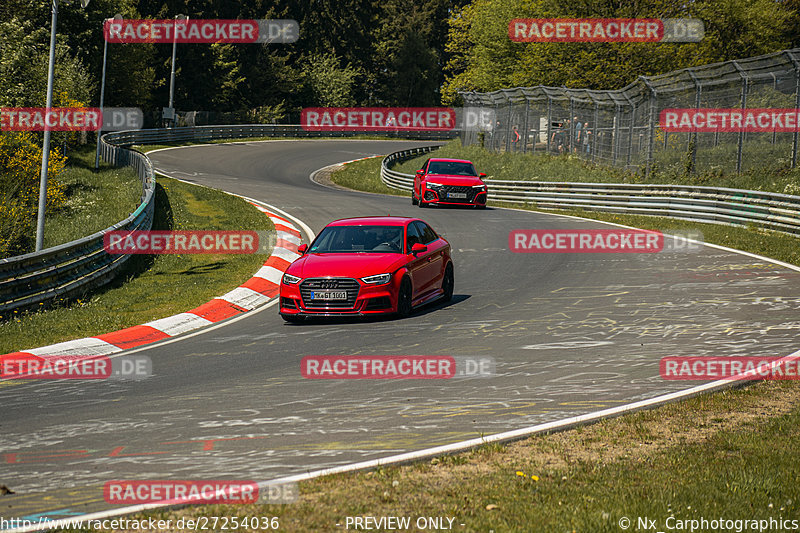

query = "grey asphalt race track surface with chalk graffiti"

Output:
[[0, 140, 800, 518]]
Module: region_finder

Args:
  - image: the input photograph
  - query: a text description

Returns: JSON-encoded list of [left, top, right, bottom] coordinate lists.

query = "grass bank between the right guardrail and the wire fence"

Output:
[[393, 139, 800, 194]]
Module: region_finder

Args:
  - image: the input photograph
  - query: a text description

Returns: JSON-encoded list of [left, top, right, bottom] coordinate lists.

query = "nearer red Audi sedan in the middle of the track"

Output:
[[280, 217, 453, 322]]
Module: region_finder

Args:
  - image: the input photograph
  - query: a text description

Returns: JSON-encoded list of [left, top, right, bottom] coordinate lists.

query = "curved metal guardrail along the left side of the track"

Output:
[[0, 124, 457, 315]]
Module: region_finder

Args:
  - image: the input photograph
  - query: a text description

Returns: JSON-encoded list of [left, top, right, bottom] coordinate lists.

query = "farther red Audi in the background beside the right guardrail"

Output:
[[411, 158, 488, 209]]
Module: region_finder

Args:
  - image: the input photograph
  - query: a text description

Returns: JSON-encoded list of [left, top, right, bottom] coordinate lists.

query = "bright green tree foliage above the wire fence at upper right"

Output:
[[442, 0, 797, 103]]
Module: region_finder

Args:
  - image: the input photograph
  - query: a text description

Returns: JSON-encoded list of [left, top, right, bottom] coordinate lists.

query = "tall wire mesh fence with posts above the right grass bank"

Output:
[[460, 48, 800, 173]]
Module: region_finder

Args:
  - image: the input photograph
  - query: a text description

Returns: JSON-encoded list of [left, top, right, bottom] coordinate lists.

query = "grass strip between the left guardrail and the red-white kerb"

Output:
[[0, 177, 274, 353]]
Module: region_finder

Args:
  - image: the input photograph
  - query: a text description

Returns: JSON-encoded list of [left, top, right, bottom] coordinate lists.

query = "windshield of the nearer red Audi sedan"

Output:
[[308, 222, 403, 254]]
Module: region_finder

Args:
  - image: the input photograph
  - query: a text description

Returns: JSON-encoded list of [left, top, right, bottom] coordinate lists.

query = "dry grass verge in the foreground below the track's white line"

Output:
[[59, 381, 800, 533]]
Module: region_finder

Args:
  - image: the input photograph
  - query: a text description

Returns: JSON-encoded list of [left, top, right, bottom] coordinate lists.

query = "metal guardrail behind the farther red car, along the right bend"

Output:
[[381, 146, 800, 236]]
